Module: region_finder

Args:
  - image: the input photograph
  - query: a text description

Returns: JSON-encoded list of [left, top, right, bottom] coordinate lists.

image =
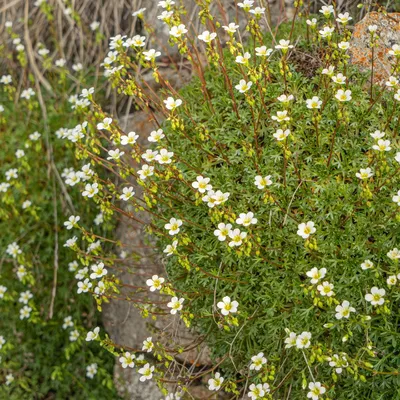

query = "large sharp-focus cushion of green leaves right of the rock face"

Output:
[[146, 22, 400, 399]]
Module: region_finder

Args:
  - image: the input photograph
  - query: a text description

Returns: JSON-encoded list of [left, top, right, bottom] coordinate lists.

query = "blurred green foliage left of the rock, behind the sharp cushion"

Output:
[[0, 84, 116, 400]]
